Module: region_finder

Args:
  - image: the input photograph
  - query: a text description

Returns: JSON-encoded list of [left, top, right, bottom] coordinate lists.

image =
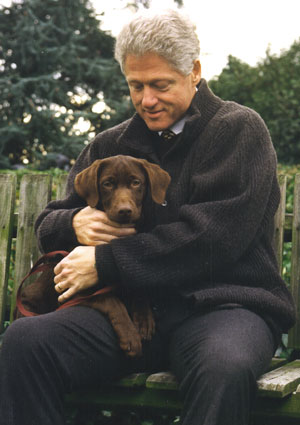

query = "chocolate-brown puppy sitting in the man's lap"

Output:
[[16, 155, 170, 357]]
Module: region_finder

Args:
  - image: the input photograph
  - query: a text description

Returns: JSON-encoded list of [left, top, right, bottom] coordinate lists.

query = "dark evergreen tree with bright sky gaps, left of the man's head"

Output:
[[0, 0, 132, 167]]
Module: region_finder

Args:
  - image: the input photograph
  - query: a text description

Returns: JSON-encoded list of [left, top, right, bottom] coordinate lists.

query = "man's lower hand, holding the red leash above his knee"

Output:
[[54, 246, 98, 302]]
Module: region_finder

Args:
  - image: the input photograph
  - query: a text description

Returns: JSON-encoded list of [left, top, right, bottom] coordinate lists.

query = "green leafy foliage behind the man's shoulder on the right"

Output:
[[209, 40, 300, 164]]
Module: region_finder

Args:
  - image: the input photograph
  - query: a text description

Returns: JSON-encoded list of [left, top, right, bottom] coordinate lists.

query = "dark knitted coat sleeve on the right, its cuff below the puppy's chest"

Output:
[[96, 109, 280, 289]]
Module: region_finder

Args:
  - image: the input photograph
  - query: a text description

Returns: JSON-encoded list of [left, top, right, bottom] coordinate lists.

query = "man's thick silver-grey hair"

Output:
[[115, 10, 200, 76]]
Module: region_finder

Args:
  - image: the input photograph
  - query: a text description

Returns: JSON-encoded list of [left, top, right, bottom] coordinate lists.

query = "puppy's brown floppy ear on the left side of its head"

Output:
[[74, 159, 103, 208]]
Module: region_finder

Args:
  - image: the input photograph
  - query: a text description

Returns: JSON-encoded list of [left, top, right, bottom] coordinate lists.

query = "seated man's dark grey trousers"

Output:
[[0, 307, 275, 425]]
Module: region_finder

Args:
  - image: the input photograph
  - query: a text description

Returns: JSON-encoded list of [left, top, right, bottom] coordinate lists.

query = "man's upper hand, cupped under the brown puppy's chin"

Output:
[[72, 207, 136, 246]]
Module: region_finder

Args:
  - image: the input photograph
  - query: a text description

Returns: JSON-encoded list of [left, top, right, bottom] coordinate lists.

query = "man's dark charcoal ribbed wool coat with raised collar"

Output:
[[36, 80, 295, 331]]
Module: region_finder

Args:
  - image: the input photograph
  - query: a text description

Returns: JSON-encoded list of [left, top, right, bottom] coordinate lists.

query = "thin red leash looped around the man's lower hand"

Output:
[[16, 251, 114, 317]]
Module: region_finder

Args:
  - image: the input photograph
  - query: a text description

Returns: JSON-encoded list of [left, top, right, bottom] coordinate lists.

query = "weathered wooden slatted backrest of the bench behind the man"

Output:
[[0, 174, 300, 349]]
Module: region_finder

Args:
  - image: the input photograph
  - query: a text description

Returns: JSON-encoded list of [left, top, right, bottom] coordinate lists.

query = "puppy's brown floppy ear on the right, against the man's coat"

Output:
[[138, 159, 171, 204]]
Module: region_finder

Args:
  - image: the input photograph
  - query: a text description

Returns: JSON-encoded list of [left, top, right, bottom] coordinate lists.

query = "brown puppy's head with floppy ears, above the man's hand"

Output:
[[75, 155, 171, 223]]
